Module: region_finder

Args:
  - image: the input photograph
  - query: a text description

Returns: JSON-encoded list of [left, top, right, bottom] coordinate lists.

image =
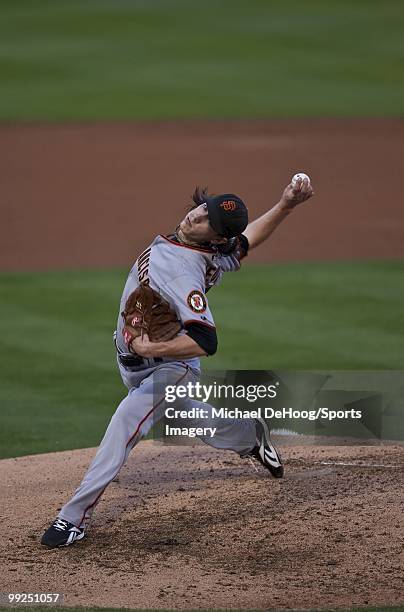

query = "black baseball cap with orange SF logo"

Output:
[[205, 193, 248, 238]]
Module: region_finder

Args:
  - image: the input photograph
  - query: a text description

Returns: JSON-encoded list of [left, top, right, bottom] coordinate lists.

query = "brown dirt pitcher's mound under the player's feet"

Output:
[[0, 442, 404, 609]]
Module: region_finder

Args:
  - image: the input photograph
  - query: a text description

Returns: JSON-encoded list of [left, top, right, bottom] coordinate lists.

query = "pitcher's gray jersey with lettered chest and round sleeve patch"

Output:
[[117, 235, 240, 369]]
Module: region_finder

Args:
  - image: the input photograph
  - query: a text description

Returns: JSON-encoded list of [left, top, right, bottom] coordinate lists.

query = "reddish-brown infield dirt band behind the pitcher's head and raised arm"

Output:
[[0, 119, 404, 270]]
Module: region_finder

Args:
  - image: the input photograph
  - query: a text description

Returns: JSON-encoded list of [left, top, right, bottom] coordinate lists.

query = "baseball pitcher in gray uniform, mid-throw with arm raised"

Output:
[[41, 178, 313, 548]]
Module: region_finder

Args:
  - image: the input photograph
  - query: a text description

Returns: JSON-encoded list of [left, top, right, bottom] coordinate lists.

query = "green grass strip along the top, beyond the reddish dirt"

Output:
[[0, 0, 404, 121]]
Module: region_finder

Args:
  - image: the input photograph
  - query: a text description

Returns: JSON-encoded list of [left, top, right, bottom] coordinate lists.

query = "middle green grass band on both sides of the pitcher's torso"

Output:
[[0, 262, 404, 457]]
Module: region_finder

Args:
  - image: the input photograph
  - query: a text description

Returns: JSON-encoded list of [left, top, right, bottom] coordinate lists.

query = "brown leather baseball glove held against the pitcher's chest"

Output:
[[121, 284, 181, 350]]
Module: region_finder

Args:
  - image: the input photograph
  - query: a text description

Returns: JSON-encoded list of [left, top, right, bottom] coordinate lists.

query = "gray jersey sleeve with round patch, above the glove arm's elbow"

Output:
[[160, 274, 215, 327]]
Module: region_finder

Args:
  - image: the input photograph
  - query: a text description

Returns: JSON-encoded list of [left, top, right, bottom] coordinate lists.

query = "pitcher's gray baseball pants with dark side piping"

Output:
[[59, 362, 256, 527]]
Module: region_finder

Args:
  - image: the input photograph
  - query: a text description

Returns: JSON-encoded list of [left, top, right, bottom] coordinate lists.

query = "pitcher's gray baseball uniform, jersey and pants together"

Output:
[[59, 235, 256, 527]]
